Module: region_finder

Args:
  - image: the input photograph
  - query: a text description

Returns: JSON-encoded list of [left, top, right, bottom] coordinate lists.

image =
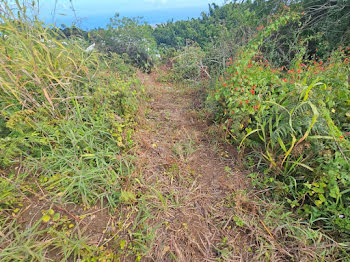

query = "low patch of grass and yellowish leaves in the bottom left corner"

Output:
[[0, 214, 97, 261]]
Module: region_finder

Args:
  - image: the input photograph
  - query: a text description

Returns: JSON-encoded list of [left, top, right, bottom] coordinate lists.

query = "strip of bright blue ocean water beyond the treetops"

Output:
[[46, 8, 207, 30]]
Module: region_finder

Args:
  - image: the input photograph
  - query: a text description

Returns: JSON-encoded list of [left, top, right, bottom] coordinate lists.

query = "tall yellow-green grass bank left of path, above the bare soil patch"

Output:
[[0, 2, 142, 206]]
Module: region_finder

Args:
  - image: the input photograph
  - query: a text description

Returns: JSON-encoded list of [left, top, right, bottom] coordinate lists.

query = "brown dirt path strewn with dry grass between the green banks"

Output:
[[135, 70, 249, 262]]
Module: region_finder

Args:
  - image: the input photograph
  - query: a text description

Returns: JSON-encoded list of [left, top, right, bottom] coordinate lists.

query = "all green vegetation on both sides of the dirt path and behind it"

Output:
[[0, 0, 350, 261]]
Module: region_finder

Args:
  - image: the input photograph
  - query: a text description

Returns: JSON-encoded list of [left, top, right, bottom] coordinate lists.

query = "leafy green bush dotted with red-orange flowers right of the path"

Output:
[[209, 11, 350, 238]]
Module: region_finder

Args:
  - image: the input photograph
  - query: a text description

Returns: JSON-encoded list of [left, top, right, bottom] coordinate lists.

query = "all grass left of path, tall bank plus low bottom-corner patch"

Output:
[[0, 1, 142, 261]]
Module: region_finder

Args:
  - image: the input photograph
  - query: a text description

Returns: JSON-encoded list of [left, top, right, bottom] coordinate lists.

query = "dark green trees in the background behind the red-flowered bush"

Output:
[[153, 0, 350, 74]]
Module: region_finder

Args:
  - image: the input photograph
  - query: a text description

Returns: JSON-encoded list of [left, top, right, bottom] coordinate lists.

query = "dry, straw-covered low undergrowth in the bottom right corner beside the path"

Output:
[[217, 190, 346, 261]]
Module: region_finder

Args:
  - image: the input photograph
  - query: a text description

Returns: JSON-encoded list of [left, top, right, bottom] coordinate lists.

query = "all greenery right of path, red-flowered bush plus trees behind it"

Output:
[[154, 1, 350, 258]]
